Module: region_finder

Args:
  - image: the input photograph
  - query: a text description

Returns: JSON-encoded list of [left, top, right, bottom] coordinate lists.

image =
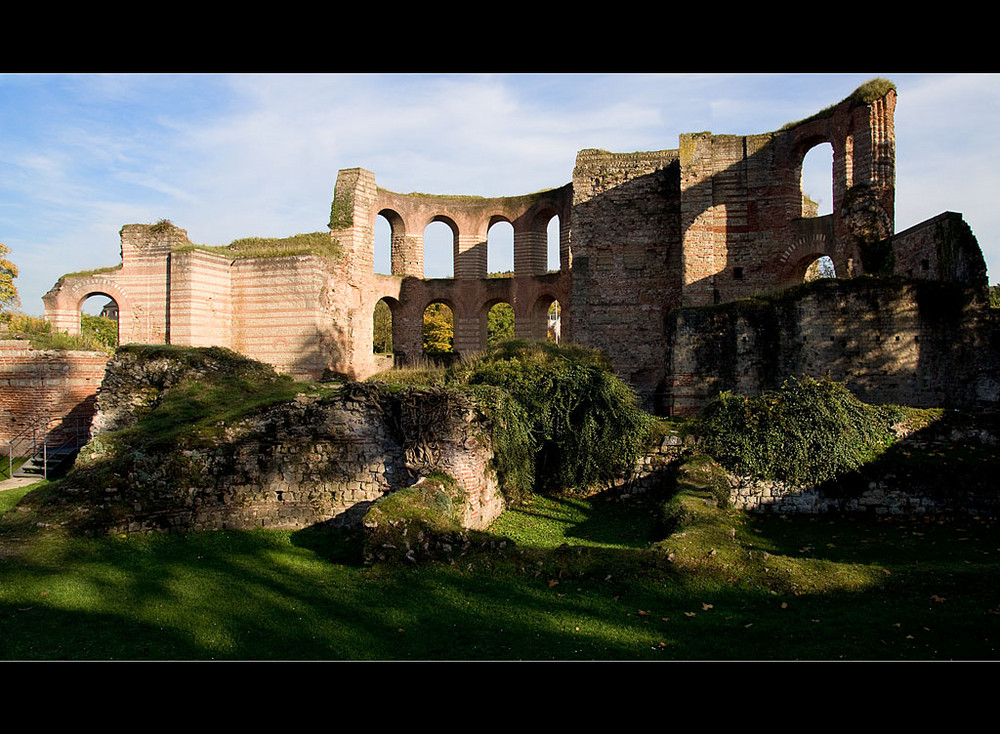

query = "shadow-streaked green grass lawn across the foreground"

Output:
[[0, 480, 1000, 660]]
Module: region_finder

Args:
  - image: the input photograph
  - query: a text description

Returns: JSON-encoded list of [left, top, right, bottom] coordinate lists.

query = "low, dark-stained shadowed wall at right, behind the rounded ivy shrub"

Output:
[[664, 279, 1000, 415]]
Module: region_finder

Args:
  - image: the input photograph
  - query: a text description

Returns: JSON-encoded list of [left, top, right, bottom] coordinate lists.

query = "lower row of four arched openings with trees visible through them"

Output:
[[372, 298, 562, 356]]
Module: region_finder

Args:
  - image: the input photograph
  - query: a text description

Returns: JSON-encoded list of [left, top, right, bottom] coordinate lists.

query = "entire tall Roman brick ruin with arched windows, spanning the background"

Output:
[[27, 80, 986, 426]]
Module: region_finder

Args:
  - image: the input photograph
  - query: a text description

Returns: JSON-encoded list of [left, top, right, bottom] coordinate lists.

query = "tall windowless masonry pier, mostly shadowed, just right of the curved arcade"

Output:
[[570, 150, 681, 402]]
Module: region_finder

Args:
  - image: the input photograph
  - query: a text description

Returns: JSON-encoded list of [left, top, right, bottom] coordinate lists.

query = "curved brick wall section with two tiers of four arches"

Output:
[[330, 169, 572, 379]]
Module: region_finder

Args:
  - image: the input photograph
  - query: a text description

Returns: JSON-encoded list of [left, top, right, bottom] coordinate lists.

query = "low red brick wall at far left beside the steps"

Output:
[[0, 339, 108, 455]]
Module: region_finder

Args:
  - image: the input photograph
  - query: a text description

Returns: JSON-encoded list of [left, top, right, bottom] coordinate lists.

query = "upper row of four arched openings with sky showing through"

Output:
[[372, 214, 561, 278]]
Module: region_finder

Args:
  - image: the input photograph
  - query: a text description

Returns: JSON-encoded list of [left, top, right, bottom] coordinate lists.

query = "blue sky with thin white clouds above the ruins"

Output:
[[0, 70, 1000, 316]]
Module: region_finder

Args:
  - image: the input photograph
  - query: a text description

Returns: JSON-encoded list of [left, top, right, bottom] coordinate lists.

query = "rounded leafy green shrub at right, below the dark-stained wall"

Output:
[[696, 377, 907, 484]]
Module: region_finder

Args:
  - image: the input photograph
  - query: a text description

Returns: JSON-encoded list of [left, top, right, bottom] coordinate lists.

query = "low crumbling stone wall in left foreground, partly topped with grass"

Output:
[[42, 349, 503, 534]]
